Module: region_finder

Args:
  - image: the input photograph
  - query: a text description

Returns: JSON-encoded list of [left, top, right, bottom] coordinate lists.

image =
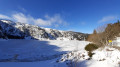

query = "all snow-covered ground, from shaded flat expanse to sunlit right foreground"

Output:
[[0, 39, 120, 67]]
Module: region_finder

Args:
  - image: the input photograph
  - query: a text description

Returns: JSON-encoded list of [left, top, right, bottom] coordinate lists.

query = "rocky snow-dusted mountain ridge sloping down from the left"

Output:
[[0, 20, 88, 40]]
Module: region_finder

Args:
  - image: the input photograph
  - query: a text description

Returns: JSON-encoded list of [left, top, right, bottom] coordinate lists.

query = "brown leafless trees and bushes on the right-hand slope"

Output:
[[87, 21, 120, 46]]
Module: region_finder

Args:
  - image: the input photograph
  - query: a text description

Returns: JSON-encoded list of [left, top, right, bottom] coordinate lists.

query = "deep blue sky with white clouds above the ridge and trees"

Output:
[[0, 0, 120, 33]]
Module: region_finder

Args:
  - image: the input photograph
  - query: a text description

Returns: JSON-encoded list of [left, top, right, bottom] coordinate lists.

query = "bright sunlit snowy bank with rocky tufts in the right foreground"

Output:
[[59, 47, 120, 67]]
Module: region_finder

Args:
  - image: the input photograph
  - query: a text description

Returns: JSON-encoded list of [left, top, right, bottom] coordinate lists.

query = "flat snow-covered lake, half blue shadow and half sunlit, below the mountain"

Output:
[[0, 39, 89, 61]]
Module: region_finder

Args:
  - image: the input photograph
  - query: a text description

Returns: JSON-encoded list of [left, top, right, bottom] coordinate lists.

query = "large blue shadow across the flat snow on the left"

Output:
[[0, 40, 66, 62]]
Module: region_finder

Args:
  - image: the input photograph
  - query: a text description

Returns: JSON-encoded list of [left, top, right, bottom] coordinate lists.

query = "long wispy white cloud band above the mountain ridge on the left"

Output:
[[0, 13, 67, 27]]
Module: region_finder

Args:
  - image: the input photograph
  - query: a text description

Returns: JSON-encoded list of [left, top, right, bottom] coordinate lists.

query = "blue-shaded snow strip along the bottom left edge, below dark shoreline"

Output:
[[0, 59, 67, 67]]
